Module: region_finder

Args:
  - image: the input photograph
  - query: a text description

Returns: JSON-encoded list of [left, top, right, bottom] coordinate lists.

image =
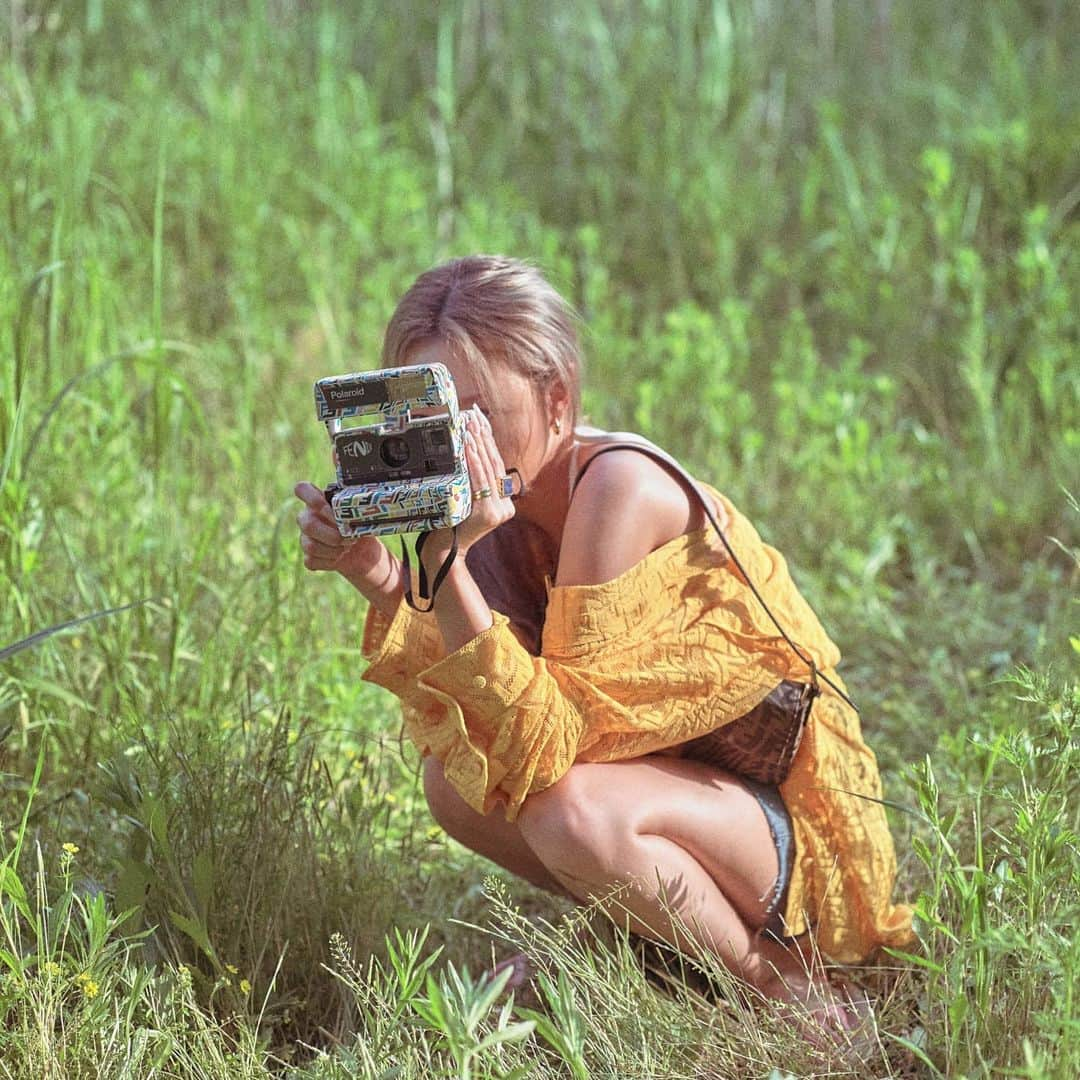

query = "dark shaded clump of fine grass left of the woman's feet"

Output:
[[95, 710, 409, 1037]]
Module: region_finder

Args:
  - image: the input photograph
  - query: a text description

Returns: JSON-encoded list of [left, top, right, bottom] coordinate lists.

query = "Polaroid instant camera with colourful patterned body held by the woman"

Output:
[[314, 364, 472, 537]]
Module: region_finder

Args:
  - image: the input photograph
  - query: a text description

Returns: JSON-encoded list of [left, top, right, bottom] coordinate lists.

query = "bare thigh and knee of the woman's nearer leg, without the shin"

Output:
[[518, 754, 780, 929]]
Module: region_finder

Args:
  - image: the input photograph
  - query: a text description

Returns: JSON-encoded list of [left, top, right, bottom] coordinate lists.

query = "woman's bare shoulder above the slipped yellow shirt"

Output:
[[555, 449, 705, 585]]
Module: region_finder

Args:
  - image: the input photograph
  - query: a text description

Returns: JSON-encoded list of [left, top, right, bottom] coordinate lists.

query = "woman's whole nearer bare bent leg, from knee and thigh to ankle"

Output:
[[516, 755, 811, 999]]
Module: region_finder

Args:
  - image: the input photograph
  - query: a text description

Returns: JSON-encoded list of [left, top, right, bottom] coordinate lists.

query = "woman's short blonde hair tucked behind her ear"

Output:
[[382, 255, 581, 430]]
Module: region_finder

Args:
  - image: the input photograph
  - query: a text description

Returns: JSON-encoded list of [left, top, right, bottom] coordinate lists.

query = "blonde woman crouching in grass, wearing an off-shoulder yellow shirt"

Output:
[[296, 256, 912, 1024]]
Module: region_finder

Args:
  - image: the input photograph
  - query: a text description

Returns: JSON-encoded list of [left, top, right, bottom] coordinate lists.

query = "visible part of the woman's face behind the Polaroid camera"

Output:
[[408, 341, 552, 489]]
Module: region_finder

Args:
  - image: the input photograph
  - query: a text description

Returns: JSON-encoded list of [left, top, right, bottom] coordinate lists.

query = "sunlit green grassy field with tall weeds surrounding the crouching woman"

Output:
[[0, 0, 1080, 1080]]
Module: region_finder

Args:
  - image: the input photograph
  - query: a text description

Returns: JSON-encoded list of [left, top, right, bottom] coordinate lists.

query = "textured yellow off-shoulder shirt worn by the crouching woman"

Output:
[[364, 488, 913, 962]]
